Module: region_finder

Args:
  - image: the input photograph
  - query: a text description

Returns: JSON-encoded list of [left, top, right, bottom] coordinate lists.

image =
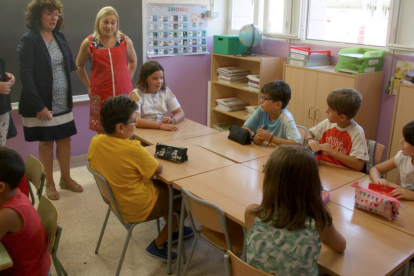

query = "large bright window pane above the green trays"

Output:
[[306, 0, 390, 46]]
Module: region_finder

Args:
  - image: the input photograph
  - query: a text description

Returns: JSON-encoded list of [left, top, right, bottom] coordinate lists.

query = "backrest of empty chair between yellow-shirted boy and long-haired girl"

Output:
[[181, 188, 232, 249]]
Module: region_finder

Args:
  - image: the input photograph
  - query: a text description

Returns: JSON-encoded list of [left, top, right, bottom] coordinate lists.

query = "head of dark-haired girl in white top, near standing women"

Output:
[[135, 60, 167, 92]]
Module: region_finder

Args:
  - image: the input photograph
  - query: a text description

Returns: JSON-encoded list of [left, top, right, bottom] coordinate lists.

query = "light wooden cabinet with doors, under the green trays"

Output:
[[283, 64, 383, 140]]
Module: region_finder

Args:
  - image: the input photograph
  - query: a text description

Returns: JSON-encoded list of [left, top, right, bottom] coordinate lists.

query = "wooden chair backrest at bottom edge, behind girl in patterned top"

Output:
[[224, 250, 271, 276]]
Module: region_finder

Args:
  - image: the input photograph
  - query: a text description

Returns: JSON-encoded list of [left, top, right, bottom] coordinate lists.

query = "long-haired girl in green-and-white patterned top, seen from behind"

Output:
[[245, 145, 346, 276]]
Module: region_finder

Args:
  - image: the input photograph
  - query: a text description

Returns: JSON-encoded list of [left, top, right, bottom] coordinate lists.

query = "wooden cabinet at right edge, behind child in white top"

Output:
[[387, 83, 414, 183]]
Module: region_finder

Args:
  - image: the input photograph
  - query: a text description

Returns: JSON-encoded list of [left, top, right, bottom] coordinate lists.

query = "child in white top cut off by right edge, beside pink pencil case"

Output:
[[369, 121, 414, 200]]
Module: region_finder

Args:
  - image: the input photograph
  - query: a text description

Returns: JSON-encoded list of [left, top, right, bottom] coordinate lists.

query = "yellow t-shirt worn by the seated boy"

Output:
[[88, 134, 158, 222]]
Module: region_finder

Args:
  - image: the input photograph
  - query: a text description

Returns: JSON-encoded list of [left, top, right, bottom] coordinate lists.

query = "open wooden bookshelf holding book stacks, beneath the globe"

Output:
[[208, 53, 286, 127]]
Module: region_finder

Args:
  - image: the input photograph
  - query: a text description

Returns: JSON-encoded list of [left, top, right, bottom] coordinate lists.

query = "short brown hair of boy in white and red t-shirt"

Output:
[[327, 88, 362, 120]]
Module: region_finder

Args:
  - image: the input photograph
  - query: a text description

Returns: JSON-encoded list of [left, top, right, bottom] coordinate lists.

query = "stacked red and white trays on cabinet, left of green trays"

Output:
[[288, 46, 331, 67]]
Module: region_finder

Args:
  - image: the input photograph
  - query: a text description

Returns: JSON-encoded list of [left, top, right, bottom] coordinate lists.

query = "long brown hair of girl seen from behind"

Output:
[[255, 145, 332, 230]]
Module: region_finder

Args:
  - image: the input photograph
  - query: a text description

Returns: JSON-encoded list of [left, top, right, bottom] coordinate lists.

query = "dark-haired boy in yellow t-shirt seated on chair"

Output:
[[88, 95, 193, 260]]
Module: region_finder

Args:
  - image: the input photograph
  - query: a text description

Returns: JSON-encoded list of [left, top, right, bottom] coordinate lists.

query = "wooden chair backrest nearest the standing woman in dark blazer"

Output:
[[25, 154, 46, 200]]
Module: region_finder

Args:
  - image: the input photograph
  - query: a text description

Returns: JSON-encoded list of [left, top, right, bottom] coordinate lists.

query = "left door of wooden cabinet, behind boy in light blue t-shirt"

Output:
[[285, 66, 317, 128]]
